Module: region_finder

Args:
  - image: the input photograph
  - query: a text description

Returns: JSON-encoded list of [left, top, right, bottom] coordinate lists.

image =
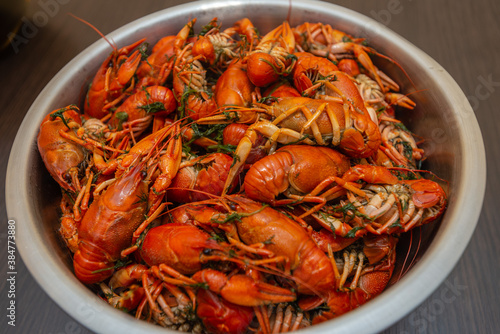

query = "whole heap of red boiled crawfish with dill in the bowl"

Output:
[[38, 19, 446, 333]]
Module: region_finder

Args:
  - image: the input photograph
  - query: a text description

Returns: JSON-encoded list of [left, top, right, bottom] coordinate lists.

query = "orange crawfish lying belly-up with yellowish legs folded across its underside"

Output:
[[214, 97, 381, 190]]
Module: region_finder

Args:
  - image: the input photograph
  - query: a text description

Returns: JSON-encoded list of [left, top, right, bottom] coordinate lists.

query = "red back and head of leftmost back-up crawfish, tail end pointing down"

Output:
[[73, 164, 148, 284]]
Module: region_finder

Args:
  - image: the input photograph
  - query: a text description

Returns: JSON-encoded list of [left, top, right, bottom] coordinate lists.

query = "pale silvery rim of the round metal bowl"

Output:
[[5, 0, 486, 333]]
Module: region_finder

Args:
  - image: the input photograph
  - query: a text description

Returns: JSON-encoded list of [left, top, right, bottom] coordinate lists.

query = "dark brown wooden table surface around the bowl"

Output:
[[0, 0, 500, 334]]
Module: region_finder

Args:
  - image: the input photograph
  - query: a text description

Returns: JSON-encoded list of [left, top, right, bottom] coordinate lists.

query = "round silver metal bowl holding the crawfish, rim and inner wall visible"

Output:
[[6, 0, 486, 334]]
